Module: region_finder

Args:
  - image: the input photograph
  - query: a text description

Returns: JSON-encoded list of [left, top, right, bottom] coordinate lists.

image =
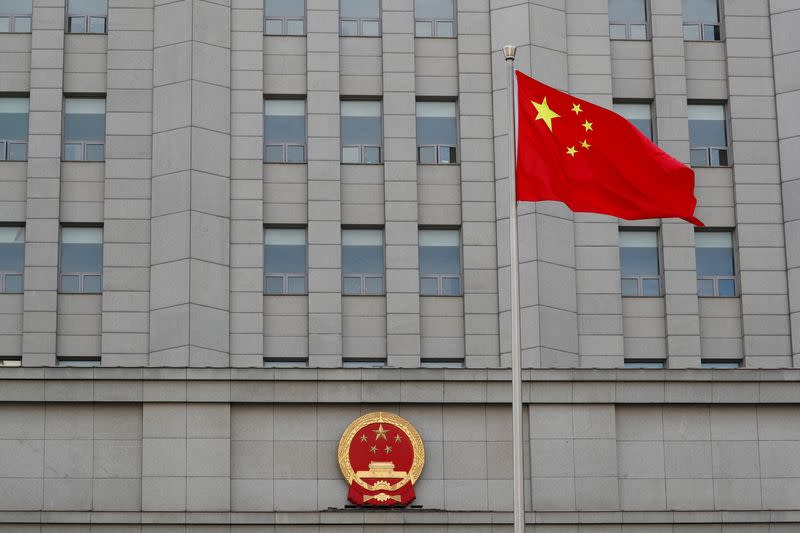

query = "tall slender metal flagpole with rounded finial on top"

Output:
[[503, 44, 525, 533]]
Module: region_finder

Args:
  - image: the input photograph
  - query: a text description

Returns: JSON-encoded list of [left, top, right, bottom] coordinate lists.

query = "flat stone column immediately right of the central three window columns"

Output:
[[456, 0, 500, 367]]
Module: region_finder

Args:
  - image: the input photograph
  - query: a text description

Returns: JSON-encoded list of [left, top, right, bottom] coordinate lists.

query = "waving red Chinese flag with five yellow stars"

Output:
[[517, 71, 703, 226]]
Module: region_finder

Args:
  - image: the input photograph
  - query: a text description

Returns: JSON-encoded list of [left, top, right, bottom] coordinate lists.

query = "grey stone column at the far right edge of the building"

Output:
[[768, 0, 800, 367]]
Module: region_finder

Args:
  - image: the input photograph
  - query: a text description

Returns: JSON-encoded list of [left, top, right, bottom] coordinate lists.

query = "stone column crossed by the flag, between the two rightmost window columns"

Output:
[[651, 0, 700, 367]]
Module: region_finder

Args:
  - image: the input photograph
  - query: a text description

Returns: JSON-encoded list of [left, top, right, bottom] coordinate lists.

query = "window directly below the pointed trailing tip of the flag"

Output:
[[694, 231, 736, 297]]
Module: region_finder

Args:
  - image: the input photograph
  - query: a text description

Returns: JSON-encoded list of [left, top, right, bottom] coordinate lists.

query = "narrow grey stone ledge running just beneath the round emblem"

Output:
[[0, 508, 800, 525]]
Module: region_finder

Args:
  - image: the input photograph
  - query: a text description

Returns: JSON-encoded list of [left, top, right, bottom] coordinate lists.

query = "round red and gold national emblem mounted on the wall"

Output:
[[339, 412, 425, 507]]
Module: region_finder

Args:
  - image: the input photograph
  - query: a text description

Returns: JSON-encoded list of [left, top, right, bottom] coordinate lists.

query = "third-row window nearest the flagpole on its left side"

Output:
[[419, 229, 461, 296]]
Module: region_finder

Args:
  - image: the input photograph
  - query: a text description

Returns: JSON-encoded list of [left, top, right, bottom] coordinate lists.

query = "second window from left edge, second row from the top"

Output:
[[64, 98, 106, 161]]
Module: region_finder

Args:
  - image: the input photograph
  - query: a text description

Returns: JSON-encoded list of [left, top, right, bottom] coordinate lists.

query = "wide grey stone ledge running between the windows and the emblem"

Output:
[[0, 368, 800, 405]]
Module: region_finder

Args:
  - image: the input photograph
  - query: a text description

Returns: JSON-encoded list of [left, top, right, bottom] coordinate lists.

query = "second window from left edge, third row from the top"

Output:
[[59, 227, 103, 293]]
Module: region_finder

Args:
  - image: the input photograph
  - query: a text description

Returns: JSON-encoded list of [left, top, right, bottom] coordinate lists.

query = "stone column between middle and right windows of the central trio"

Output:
[[383, 0, 420, 367]]
